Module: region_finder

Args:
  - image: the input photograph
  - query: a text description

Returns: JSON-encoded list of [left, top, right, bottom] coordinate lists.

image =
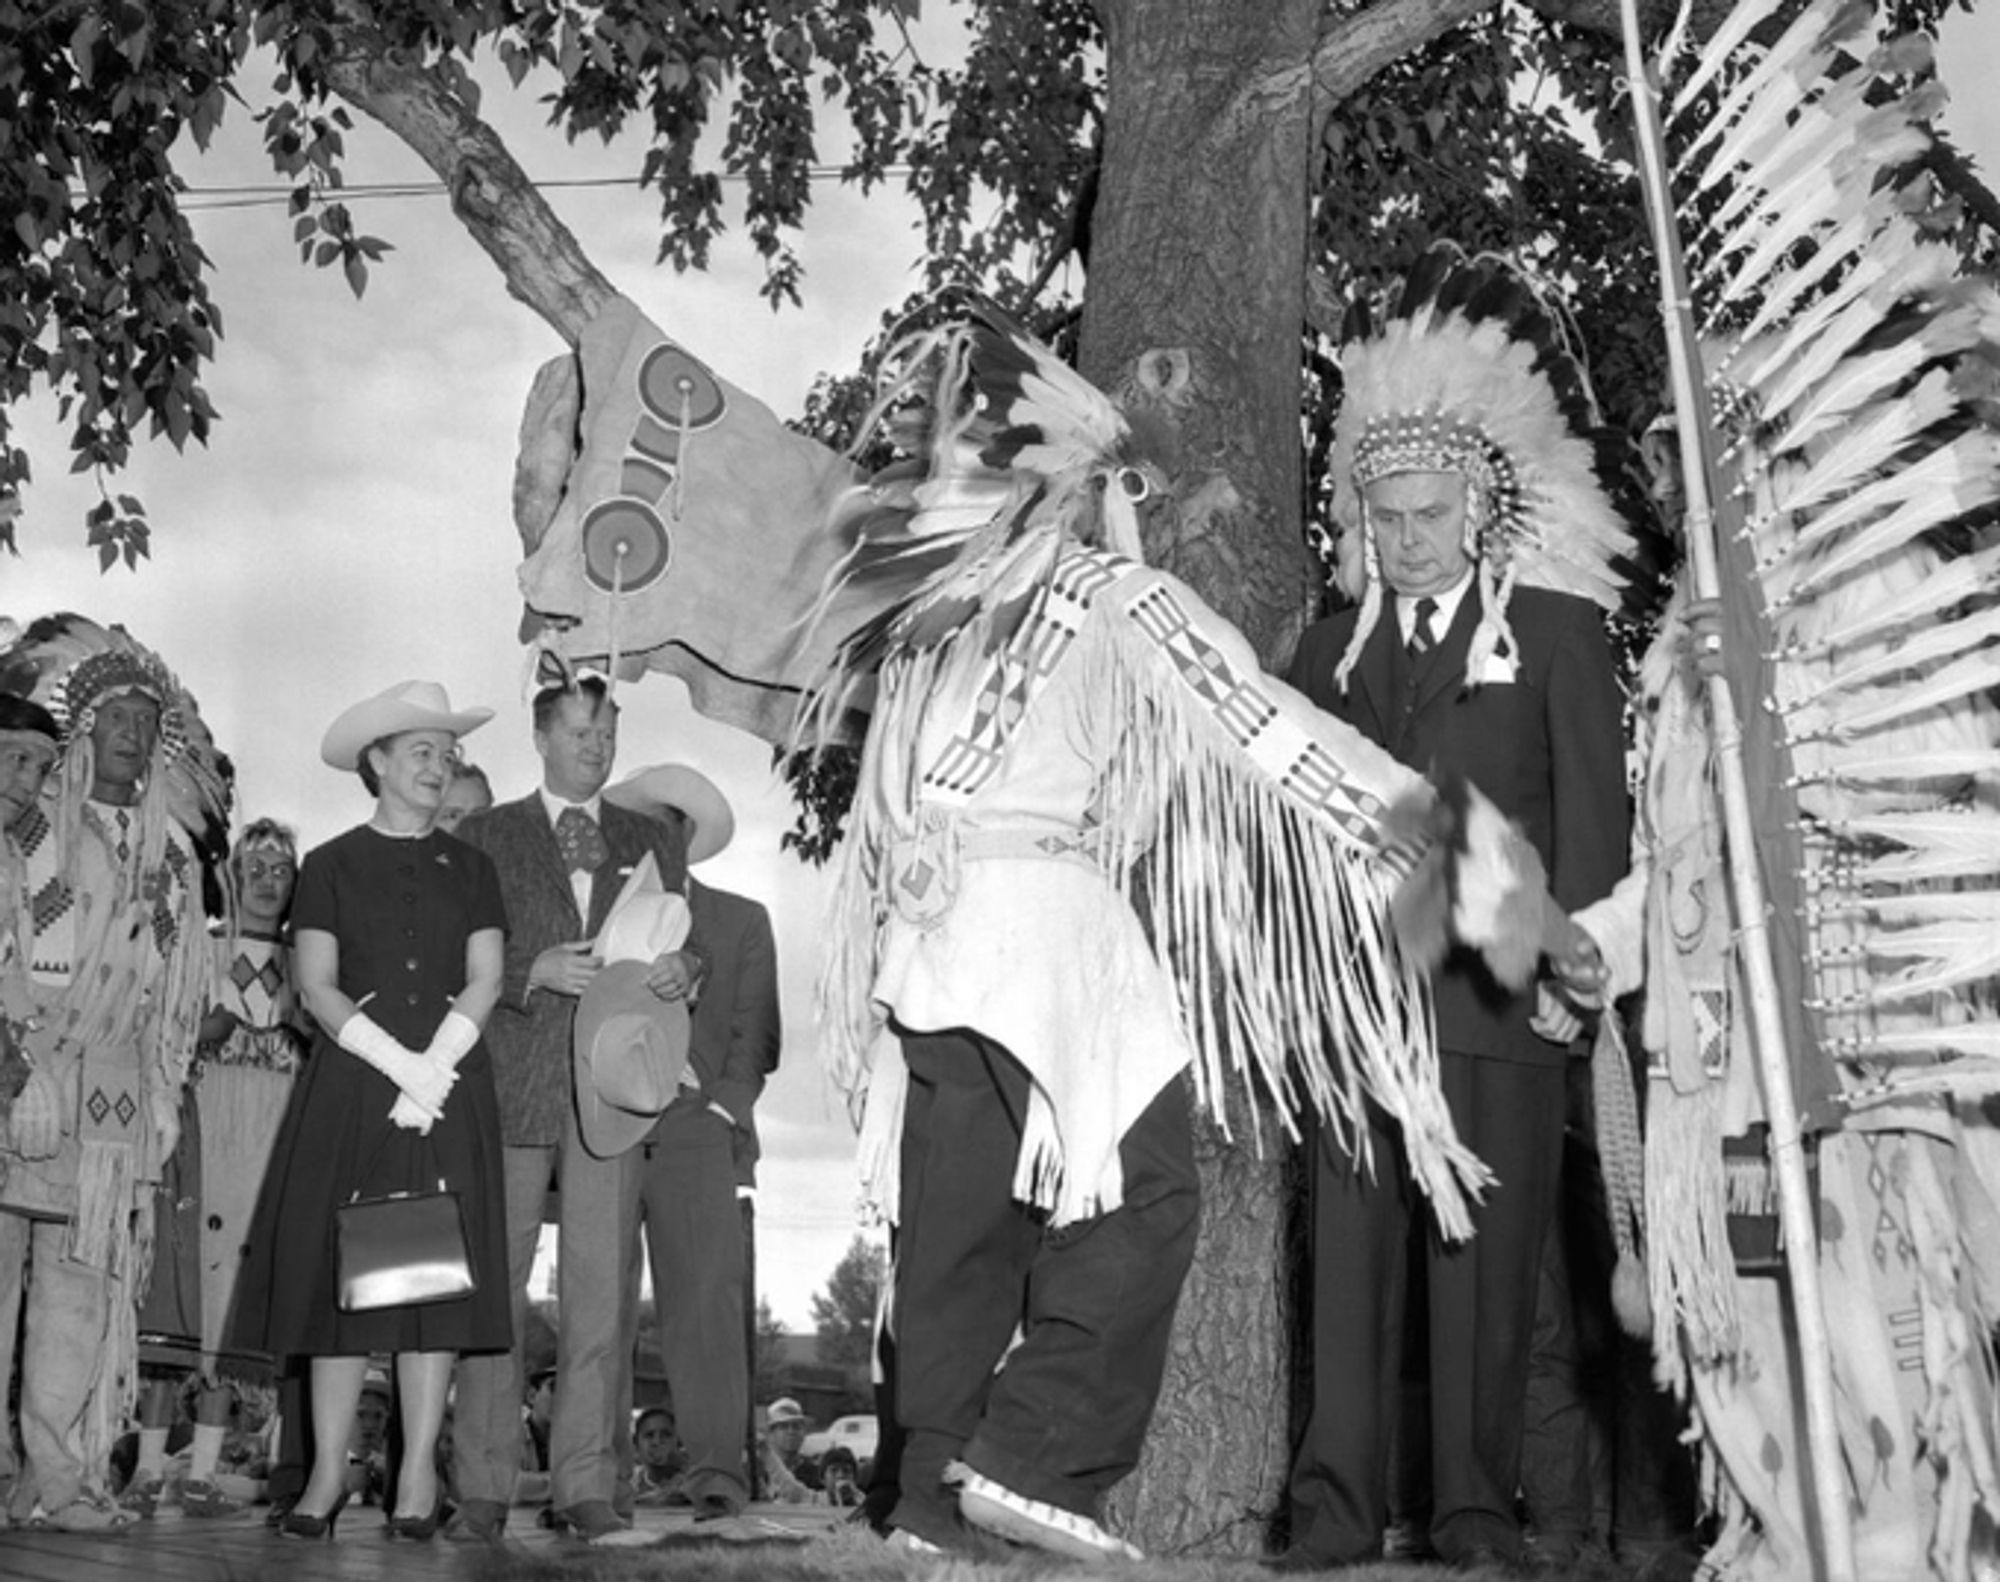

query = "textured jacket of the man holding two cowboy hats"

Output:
[[458, 790, 702, 1148]]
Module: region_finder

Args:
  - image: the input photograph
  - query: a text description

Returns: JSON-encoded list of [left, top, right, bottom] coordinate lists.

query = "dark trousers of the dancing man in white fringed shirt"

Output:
[[892, 1032, 1200, 1542]]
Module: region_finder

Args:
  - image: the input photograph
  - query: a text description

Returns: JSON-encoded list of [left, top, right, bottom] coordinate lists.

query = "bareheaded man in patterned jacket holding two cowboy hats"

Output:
[[446, 676, 702, 1540]]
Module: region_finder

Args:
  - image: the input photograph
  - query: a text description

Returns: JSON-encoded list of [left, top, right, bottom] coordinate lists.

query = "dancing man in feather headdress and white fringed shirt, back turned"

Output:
[[802, 318, 1546, 1556]]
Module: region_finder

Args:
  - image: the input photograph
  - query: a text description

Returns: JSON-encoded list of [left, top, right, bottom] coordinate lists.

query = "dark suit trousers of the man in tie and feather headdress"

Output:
[[1290, 1052, 1564, 1564]]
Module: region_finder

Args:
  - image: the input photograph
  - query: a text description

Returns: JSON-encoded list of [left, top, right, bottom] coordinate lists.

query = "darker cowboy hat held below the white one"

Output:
[[570, 962, 688, 1160]]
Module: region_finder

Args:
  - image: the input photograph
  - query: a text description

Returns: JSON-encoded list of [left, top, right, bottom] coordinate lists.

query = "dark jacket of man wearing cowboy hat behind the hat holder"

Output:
[[662, 876, 784, 1186]]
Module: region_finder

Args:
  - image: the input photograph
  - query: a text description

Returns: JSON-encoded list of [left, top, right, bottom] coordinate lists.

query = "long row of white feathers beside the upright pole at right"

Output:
[[1674, 0, 2000, 1092]]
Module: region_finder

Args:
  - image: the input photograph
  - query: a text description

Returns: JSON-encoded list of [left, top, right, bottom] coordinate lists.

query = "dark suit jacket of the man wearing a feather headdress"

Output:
[[1292, 588, 1630, 1062]]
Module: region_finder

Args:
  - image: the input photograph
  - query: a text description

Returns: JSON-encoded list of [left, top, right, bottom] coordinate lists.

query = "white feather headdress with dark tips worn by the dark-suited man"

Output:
[[1330, 242, 1634, 684]]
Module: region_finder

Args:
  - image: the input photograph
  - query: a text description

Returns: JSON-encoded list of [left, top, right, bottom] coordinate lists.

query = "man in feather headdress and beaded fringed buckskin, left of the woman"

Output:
[[0, 616, 226, 1532]]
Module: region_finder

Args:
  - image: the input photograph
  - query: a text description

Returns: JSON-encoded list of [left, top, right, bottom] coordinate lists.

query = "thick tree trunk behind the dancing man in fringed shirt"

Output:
[[1080, 0, 1320, 1554]]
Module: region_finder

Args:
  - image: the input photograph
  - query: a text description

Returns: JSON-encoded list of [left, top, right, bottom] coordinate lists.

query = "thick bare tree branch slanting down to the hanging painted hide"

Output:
[[326, 4, 618, 346]]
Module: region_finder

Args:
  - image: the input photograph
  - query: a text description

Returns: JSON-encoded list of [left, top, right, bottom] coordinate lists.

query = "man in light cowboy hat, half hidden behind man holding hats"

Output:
[[604, 764, 782, 1518]]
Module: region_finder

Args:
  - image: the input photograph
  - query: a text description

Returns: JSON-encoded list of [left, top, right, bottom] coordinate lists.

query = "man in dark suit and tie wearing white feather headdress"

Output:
[[1292, 246, 1630, 1566]]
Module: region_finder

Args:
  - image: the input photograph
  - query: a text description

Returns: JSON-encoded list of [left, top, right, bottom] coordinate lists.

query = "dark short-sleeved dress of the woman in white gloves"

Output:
[[232, 824, 512, 1356]]
